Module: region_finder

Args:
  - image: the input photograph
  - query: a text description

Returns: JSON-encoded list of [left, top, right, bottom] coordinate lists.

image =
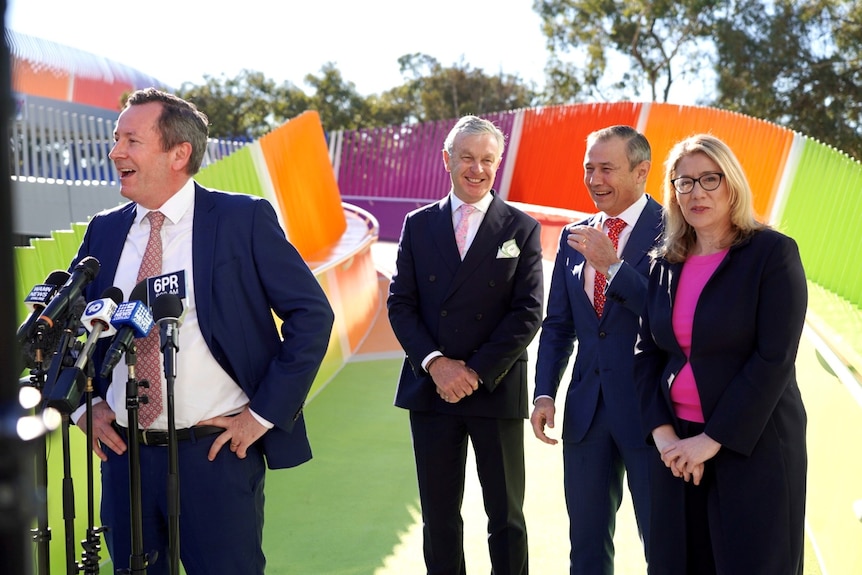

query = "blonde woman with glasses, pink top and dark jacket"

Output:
[[635, 134, 807, 575]]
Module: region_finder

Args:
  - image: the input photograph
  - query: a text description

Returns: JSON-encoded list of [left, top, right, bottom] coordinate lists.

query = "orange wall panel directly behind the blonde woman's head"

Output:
[[644, 103, 793, 222]]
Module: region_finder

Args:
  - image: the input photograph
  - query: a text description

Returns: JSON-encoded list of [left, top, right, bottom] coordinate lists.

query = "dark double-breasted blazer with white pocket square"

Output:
[[387, 192, 544, 418]]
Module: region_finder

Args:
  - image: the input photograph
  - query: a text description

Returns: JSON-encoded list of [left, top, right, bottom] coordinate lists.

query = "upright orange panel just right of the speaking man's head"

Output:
[[260, 111, 347, 259]]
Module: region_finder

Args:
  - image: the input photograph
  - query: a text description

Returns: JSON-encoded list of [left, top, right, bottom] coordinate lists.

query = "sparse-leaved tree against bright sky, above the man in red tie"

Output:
[[533, 0, 728, 104]]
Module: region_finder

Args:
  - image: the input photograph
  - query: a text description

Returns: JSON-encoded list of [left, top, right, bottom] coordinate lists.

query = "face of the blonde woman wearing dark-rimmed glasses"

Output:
[[674, 152, 732, 241]]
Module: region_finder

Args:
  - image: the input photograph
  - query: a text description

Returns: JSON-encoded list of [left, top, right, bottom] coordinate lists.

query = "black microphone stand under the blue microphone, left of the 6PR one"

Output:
[[125, 342, 151, 575]]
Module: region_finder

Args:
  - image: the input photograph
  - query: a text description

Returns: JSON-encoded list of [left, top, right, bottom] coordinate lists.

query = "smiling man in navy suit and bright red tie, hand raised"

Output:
[[530, 126, 661, 575]]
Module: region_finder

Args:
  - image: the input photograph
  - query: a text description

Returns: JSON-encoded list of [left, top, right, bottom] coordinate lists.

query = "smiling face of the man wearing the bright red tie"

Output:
[[584, 137, 650, 217]]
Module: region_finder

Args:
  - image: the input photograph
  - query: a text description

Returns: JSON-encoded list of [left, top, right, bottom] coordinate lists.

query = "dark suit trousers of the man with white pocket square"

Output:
[[410, 411, 529, 575]]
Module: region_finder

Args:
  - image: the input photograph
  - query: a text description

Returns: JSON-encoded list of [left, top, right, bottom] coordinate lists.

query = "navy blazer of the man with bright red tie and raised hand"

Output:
[[534, 196, 662, 445]]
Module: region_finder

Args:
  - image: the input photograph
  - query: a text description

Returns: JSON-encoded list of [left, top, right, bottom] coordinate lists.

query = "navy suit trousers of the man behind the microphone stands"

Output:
[[102, 428, 266, 575]]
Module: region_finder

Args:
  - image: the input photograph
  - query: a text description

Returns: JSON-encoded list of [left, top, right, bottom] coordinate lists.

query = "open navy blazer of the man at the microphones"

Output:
[[75, 183, 334, 468]]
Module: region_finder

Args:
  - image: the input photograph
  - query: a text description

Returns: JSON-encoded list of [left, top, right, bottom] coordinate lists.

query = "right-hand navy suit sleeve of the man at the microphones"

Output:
[[245, 201, 334, 430]]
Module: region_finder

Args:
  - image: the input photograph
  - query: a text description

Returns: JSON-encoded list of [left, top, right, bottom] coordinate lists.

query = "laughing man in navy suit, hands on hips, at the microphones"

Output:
[[73, 89, 333, 575]]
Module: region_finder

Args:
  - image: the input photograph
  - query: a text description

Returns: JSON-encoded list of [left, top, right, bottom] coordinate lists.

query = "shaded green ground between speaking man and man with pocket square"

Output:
[[264, 360, 419, 575]]
